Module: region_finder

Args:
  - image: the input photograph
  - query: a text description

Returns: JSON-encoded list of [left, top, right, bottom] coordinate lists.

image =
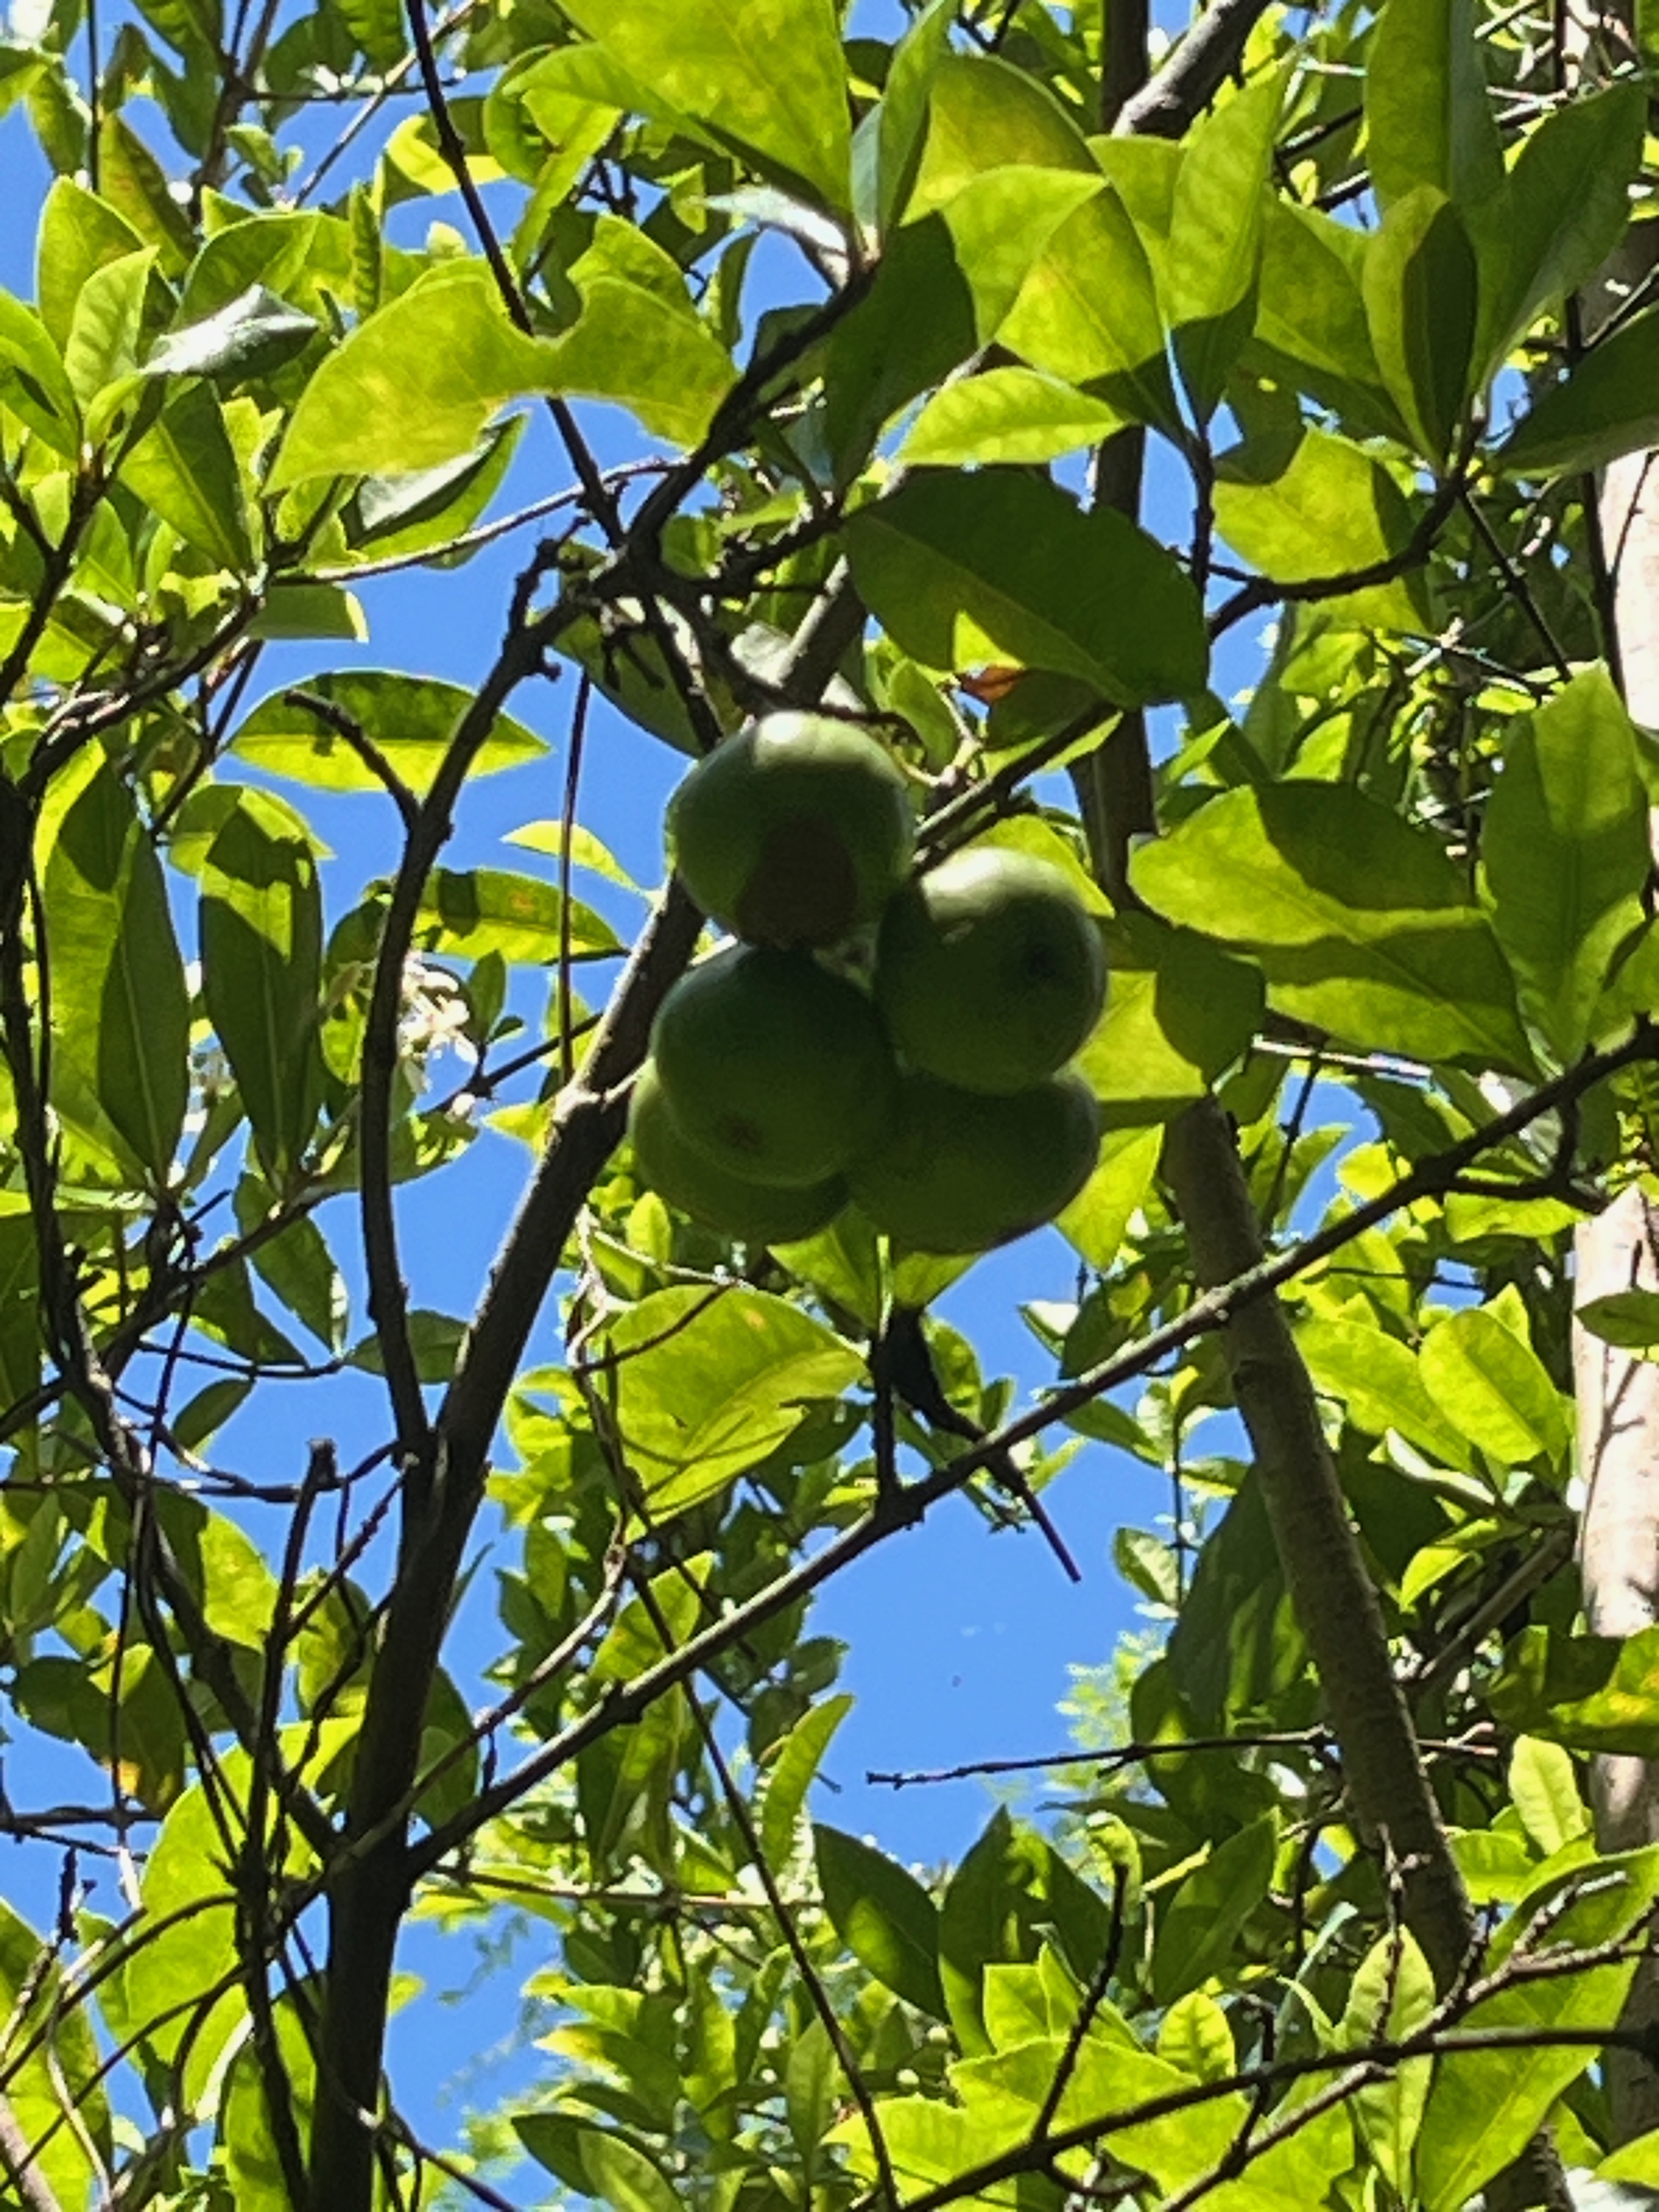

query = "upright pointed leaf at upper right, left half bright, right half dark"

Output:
[[1365, 184, 1477, 462]]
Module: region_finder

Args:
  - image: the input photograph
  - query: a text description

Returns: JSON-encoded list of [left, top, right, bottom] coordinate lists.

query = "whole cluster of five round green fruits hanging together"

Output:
[[628, 714, 1106, 1252]]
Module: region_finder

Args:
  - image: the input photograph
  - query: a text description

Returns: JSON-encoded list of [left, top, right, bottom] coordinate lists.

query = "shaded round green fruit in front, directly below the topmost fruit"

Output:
[[650, 945, 898, 1190]]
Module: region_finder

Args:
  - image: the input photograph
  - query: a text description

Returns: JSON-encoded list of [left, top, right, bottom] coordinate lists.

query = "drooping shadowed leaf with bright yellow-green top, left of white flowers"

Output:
[[201, 789, 323, 1190]]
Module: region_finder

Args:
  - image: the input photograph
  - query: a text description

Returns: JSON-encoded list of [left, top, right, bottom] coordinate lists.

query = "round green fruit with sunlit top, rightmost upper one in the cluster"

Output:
[[876, 845, 1106, 1093]]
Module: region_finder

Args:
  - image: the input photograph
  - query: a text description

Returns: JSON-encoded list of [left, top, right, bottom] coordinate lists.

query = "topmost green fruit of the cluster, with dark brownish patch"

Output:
[[668, 714, 913, 945]]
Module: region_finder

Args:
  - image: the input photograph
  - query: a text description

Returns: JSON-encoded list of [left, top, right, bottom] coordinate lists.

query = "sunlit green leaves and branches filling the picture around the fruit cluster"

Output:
[[0, 0, 1659, 2212]]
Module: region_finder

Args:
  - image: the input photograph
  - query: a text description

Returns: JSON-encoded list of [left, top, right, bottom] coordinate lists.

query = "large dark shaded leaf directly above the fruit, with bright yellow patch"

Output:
[[845, 469, 1207, 706]]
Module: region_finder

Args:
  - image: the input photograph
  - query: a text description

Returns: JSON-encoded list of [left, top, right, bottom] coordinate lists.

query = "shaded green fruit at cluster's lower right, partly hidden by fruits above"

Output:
[[847, 1075, 1099, 1252]]
